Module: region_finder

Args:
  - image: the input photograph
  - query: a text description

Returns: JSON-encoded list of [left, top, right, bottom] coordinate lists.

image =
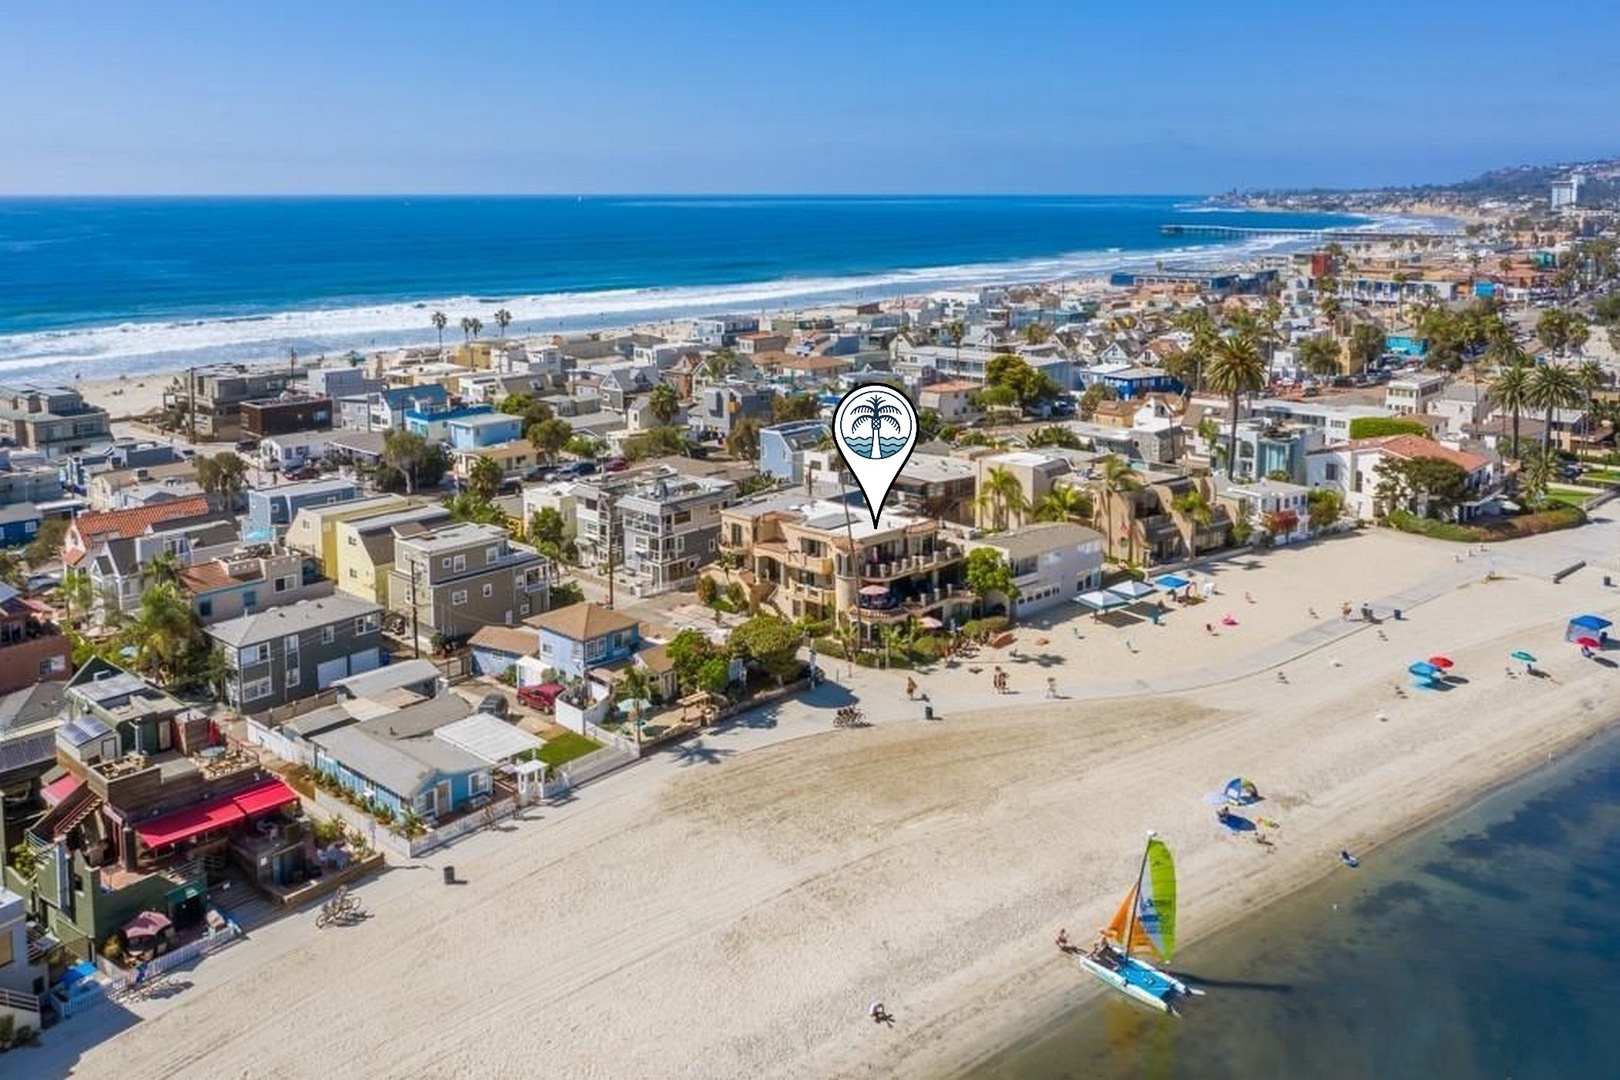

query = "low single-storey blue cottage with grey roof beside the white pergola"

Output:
[[294, 695, 499, 819]]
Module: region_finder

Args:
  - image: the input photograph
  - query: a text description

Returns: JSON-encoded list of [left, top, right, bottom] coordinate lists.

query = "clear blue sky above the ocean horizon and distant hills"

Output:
[[0, 0, 1620, 194]]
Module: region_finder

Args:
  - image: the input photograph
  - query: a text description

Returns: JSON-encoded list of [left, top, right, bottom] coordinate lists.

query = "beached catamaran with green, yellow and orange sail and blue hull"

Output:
[[1074, 832, 1204, 1012]]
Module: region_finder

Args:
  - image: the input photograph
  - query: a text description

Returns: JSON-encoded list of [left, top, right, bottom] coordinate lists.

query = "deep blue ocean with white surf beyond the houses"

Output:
[[0, 196, 1393, 377]]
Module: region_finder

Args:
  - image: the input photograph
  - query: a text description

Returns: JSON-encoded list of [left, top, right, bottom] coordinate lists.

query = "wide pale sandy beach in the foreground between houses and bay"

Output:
[[34, 521, 1620, 1080]]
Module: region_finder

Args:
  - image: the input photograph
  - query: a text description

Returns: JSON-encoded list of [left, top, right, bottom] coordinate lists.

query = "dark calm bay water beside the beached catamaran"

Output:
[[972, 735, 1620, 1080]]
